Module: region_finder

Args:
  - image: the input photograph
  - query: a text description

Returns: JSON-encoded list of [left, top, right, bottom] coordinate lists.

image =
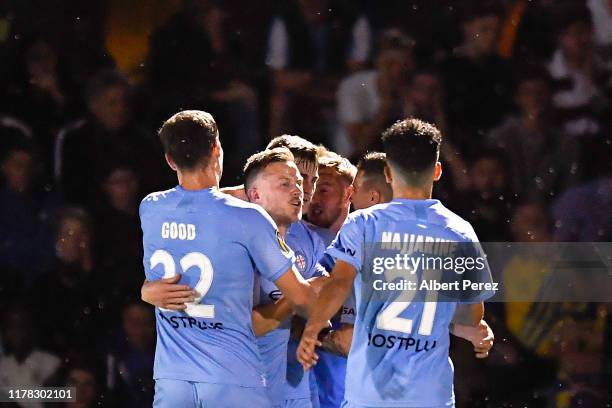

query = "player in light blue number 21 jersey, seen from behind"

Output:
[[298, 119, 490, 408]]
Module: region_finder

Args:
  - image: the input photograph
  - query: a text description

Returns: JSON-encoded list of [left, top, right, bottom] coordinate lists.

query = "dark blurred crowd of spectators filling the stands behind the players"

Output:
[[0, 0, 612, 408]]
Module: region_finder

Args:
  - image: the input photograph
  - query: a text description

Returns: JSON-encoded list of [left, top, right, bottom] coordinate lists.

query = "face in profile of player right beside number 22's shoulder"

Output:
[[252, 162, 304, 225]]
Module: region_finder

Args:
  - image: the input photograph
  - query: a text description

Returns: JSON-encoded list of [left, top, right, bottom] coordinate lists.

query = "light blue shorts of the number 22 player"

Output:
[[153, 378, 272, 408]]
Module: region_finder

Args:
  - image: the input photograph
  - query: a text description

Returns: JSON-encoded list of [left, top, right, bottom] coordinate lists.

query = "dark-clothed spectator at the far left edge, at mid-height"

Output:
[[0, 139, 59, 296]]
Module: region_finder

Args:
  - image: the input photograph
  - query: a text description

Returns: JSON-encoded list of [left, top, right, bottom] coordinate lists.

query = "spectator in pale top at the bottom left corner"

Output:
[[0, 304, 61, 408]]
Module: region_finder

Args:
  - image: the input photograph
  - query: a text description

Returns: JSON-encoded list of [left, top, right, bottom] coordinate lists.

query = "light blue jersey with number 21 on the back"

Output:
[[327, 199, 490, 407]]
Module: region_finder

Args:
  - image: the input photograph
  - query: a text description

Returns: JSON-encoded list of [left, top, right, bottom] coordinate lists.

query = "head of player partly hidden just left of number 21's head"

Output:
[[351, 152, 393, 210]]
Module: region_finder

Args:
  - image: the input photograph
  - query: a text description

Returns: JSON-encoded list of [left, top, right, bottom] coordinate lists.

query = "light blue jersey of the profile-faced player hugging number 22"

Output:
[[255, 221, 325, 404]]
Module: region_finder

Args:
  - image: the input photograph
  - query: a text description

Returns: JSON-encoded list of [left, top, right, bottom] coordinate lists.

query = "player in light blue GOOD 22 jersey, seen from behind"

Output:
[[140, 111, 314, 408]]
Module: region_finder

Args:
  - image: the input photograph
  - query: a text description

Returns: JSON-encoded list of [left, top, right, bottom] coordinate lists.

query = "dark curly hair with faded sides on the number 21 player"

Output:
[[382, 119, 442, 186]]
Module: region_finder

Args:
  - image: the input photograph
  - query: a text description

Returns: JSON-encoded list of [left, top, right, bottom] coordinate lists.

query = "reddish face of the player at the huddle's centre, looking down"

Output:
[[308, 168, 347, 228]]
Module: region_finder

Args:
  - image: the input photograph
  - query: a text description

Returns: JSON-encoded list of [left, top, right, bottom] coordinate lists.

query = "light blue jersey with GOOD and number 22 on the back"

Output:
[[140, 186, 293, 387]]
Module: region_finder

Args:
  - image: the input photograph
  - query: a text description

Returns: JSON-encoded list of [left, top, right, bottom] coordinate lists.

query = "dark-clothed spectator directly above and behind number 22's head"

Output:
[[148, 0, 261, 180]]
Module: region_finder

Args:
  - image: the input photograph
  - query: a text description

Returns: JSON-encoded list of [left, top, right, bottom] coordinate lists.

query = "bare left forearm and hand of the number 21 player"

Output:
[[297, 259, 357, 370]]
